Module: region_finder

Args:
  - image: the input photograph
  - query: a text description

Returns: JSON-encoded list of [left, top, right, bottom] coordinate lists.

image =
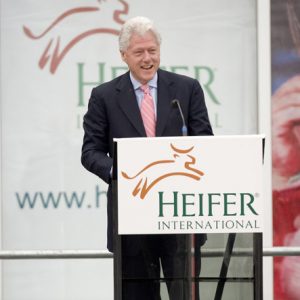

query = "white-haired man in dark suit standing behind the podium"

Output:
[[82, 17, 212, 300]]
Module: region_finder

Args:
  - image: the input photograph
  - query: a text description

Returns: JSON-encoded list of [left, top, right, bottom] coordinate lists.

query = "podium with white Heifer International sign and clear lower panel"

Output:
[[113, 135, 264, 300]]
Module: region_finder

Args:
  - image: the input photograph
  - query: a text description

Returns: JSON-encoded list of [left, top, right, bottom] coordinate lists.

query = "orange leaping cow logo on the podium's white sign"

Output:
[[121, 144, 204, 200]]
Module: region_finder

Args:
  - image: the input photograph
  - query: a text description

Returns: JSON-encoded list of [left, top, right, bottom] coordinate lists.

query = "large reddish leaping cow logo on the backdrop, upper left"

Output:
[[23, 0, 129, 74]]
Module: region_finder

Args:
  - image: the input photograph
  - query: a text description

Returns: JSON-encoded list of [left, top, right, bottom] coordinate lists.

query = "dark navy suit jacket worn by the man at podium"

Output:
[[81, 69, 213, 251]]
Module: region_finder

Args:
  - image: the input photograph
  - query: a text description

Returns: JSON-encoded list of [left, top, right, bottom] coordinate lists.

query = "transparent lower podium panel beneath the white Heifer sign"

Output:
[[120, 233, 262, 300]]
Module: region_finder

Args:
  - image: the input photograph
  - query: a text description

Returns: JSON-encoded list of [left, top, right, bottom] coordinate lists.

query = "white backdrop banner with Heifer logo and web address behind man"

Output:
[[1, 0, 257, 300]]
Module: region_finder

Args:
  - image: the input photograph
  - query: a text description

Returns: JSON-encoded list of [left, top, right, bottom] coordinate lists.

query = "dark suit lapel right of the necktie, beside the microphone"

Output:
[[156, 70, 175, 136]]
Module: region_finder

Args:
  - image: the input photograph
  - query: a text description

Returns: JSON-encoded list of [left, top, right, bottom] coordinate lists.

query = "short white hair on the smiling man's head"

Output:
[[119, 17, 161, 52]]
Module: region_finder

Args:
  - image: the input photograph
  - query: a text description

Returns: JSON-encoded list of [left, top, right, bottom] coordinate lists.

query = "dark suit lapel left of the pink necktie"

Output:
[[116, 72, 146, 136]]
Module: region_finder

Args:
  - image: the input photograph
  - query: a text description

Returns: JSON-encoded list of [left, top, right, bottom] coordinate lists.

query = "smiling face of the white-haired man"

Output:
[[121, 31, 160, 84]]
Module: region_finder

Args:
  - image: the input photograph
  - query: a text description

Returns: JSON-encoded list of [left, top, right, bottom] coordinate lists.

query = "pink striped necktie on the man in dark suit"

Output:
[[141, 85, 155, 137]]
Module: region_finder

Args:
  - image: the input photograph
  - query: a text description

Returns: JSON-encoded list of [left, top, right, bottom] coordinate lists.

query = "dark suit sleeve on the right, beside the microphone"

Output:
[[188, 80, 213, 136]]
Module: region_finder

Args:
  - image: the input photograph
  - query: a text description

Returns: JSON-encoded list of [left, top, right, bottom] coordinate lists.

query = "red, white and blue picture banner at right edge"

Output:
[[271, 0, 300, 300]]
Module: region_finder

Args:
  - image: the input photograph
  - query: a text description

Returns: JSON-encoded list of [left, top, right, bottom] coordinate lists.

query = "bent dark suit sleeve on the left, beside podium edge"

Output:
[[81, 89, 113, 183]]
